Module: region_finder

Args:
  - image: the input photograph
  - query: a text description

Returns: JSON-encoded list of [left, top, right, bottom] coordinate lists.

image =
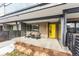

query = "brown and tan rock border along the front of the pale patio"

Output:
[[15, 42, 72, 56]]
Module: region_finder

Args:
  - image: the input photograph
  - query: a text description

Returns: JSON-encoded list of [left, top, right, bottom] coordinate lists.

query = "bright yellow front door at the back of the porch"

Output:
[[49, 23, 57, 39]]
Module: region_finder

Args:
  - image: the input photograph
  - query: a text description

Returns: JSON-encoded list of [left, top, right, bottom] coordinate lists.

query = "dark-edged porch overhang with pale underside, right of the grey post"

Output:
[[63, 7, 79, 21]]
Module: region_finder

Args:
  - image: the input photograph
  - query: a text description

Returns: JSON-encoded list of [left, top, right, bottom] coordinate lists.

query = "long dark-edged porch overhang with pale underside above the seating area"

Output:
[[0, 14, 64, 24]]
